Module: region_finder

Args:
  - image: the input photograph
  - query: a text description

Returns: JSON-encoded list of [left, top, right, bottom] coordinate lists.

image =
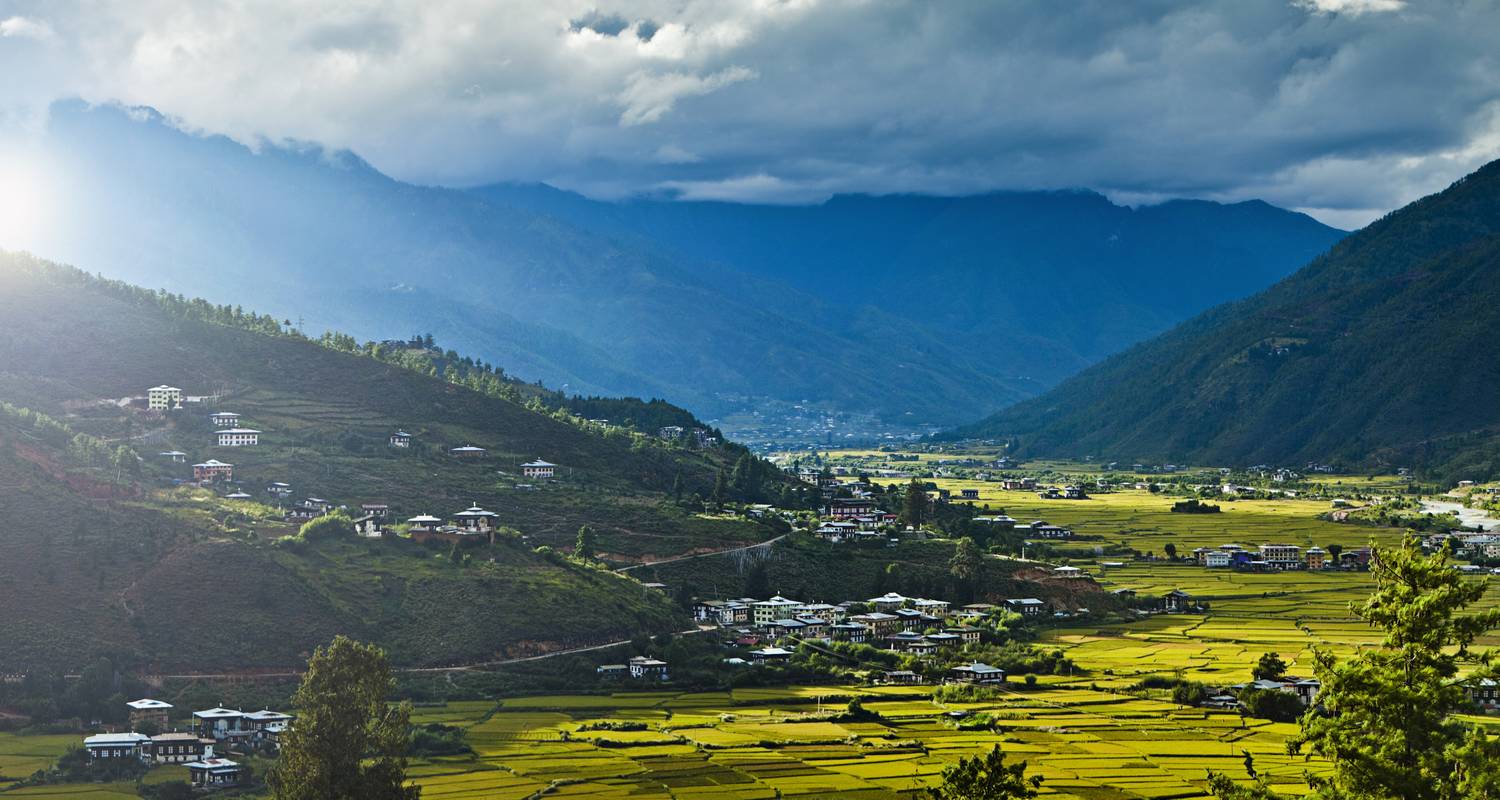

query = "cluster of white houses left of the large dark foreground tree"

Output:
[[84, 698, 293, 788]]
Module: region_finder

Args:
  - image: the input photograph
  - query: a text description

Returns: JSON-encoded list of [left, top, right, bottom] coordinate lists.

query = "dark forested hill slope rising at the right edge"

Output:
[[956, 162, 1500, 477]]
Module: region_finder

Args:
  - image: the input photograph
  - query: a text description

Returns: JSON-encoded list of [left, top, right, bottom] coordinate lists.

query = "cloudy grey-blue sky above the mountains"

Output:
[[0, 0, 1500, 228]]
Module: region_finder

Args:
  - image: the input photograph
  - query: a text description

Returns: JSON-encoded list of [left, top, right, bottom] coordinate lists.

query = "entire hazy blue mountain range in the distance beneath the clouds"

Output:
[[17, 104, 1343, 434]]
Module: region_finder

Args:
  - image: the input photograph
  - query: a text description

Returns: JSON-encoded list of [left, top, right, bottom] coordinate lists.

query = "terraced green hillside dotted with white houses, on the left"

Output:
[[0, 254, 780, 672]]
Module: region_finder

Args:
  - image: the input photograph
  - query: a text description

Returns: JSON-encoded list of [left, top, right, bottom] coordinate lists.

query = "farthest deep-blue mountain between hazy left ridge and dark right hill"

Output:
[[474, 186, 1343, 367]]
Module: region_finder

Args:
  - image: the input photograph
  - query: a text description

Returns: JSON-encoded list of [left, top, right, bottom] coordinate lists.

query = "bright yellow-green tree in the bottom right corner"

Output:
[[1211, 536, 1500, 800]]
